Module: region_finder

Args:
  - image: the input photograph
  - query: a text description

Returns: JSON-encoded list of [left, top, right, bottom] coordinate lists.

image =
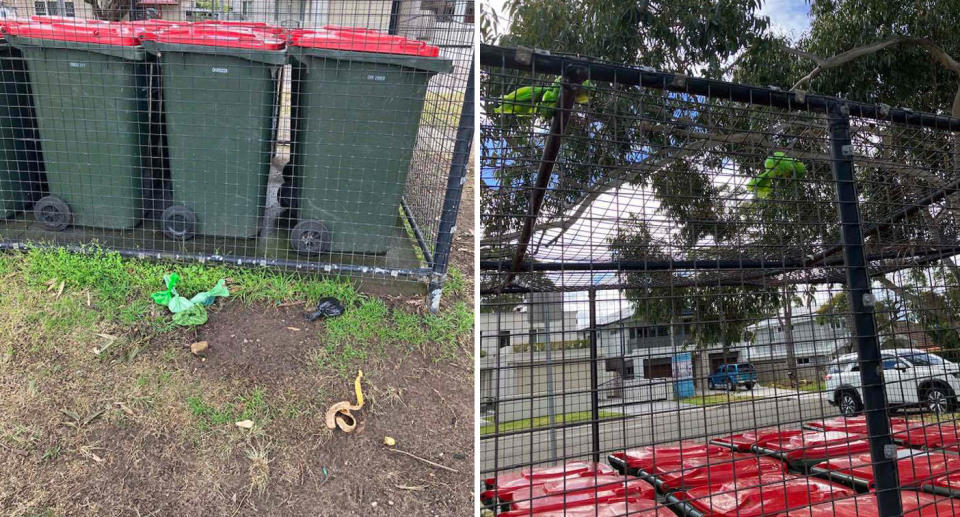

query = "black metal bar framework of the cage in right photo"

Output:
[[480, 41, 960, 517]]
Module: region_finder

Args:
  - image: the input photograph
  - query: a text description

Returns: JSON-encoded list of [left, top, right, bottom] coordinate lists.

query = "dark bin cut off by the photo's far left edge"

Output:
[[0, 27, 42, 219]]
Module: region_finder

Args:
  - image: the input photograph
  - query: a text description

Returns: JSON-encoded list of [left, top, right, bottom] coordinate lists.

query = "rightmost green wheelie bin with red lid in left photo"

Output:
[[287, 26, 452, 254]]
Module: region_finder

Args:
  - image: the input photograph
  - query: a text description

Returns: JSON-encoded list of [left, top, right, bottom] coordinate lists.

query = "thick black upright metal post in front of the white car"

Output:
[[828, 102, 903, 517]]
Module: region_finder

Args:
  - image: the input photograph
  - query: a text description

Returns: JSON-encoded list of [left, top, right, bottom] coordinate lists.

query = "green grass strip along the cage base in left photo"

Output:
[[0, 248, 473, 378]]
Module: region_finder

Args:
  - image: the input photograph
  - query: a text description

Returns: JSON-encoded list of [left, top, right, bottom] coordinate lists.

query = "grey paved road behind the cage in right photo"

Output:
[[478, 389, 838, 473]]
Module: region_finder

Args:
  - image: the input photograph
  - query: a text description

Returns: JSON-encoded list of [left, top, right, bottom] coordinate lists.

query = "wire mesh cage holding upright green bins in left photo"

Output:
[[0, 0, 474, 305]]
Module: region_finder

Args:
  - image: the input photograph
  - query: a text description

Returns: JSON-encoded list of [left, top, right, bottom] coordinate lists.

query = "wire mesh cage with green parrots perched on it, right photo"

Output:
[[477, 45, 960, 517]]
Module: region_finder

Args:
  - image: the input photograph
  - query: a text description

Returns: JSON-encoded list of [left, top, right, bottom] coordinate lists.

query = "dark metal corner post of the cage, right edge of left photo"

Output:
[[427, 59, 474, 312]]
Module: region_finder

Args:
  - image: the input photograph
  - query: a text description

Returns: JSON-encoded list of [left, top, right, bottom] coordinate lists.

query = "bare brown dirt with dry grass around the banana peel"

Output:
[[0, 294, 473, 517]]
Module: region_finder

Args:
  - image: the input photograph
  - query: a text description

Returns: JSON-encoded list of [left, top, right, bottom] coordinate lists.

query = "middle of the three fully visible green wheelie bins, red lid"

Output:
[[143, 24, 286, 240]]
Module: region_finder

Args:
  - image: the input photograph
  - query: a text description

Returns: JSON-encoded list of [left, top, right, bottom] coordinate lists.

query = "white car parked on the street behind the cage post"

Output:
[[825, 348, 960, 416]]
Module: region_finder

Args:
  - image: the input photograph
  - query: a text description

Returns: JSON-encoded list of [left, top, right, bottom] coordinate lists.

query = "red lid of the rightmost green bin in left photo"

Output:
[[290, 25, 440, 57]]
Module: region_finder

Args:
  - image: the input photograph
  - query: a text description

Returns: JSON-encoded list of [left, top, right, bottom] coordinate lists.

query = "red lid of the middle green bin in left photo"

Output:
[[141, 23, 284, 50]]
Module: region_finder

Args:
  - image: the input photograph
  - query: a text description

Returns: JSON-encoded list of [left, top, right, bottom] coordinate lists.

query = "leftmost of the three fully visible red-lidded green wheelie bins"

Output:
[[6, 21, 149, 231]]
